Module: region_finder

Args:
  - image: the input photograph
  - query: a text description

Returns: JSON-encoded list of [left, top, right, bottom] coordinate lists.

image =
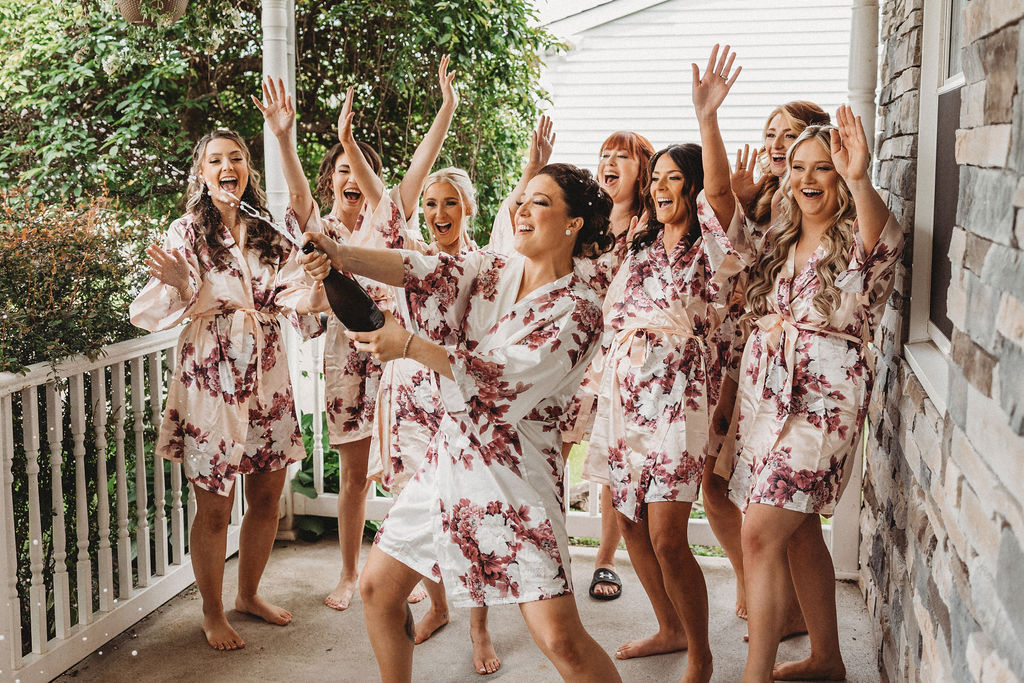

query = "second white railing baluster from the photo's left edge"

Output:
[[22, 386, 47, 654]]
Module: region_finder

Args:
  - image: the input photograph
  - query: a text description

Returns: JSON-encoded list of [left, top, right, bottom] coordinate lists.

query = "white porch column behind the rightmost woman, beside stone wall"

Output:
[[831, 0, 879, 579]]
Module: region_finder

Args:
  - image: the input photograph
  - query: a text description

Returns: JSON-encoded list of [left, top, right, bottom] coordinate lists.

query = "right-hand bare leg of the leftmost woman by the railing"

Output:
[[234, 469, 292, 626]]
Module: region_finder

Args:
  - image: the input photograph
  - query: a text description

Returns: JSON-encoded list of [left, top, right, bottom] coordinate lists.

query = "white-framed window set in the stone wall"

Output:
[[906, 0, 969, 405]]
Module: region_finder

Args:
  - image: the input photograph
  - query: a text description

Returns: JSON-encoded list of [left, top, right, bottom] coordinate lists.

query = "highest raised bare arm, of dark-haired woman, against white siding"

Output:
[[690, 45, 742, 226]]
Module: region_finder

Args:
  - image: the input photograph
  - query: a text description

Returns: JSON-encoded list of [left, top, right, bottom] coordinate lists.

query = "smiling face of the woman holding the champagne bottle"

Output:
[[513, 174, 583, 258]]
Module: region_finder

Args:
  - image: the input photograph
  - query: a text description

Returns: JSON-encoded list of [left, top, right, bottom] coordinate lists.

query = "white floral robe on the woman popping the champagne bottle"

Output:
[[377, 251, 601, 605]]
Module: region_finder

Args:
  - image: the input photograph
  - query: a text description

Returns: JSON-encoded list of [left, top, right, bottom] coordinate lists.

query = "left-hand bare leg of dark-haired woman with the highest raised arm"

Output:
[[615, 512, 686, 659]]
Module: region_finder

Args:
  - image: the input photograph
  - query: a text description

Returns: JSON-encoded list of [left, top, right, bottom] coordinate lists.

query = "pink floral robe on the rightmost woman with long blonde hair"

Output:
[[729, 216, 903, 516]]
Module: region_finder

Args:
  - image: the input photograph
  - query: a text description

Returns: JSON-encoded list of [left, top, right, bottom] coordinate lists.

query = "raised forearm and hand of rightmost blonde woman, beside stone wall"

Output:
[[831, 104, 889, 252]]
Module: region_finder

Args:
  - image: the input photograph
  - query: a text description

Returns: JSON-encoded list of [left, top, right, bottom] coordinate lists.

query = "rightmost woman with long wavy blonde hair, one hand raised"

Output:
[[729, 106, 902, 680]]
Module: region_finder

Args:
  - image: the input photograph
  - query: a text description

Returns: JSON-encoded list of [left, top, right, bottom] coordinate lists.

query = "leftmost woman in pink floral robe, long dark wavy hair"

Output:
[[130, 121, 321, 650]]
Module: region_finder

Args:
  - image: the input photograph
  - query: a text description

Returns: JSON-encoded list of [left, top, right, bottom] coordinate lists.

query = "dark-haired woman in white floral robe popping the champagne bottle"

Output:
[[307, 165, 618, 680]]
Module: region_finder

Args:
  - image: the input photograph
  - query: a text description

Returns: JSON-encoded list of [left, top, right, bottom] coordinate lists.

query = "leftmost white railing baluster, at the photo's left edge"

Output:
[[0, 393, 22, 679]]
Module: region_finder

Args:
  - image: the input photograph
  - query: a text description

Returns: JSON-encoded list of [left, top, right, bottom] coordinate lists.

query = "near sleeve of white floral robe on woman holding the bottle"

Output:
[[440, 298, 601, 426]]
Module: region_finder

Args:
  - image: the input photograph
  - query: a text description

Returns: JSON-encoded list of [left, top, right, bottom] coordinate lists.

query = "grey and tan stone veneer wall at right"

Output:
[[860, 0, 1024, 681]]
